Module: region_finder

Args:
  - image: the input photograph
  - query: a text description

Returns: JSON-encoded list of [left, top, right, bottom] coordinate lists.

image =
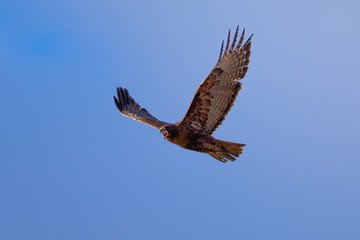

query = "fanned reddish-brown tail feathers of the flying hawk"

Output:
[[209, 140, 246, 163]]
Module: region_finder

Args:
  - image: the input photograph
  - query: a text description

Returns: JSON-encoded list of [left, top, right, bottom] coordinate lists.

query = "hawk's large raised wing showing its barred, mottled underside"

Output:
[[179, 26, 252, 134]]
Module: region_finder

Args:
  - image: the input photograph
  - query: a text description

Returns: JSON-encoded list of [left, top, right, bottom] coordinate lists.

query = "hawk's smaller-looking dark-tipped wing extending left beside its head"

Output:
[[114, 87, 168, 129]]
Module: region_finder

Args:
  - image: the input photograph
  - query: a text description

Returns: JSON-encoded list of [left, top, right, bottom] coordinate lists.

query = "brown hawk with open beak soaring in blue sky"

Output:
[[114, 26, 252, 163]]
